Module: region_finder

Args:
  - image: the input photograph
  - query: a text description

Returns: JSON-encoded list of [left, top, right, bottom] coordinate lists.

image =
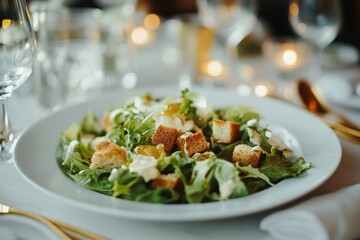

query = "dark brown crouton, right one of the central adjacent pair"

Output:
[[176, 132, 209, 157]]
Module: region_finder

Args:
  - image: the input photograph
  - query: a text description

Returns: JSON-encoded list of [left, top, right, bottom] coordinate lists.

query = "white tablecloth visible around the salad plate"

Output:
[[0, 48, 360, 240]]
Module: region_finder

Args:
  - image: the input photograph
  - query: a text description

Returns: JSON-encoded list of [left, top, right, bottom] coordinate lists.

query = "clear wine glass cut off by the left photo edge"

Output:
[[0, 0, 36, 162]]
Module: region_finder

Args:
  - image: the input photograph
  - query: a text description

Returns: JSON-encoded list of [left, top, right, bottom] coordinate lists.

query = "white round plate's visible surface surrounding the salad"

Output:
[[15, 88, 341, 221]]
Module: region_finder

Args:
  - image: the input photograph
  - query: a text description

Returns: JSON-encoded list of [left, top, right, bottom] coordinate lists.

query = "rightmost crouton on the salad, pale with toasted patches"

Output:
[[232, 144, 263, 168]]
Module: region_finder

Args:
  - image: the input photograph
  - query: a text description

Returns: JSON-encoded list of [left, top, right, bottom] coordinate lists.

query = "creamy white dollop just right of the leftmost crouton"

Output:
[[129, 155, 160, 182]]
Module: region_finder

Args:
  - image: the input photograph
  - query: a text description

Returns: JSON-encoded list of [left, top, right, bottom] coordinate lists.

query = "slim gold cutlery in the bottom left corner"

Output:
[[0, 203, 106, 240]]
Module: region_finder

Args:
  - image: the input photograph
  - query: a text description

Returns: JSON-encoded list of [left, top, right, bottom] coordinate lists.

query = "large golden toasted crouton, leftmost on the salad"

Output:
[[90, 141, 127, 170]]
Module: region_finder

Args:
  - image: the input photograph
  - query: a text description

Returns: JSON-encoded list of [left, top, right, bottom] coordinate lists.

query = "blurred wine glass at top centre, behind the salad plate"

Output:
[[197, 0, 256, 57]]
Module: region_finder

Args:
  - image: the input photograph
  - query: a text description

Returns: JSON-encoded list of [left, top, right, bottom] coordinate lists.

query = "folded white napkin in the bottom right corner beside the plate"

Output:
[[260, 184, 360, 240]]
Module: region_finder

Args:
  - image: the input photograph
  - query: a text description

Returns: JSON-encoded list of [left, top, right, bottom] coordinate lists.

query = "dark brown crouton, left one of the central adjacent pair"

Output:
[[151, 125, 181, 153]]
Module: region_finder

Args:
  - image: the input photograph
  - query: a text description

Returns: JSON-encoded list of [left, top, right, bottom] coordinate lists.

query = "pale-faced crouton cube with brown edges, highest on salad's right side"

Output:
[[213, 119, 240, 143]]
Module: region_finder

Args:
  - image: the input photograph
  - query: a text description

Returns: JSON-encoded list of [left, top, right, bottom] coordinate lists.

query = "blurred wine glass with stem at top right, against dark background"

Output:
[[289, 0, 342, 81]]
